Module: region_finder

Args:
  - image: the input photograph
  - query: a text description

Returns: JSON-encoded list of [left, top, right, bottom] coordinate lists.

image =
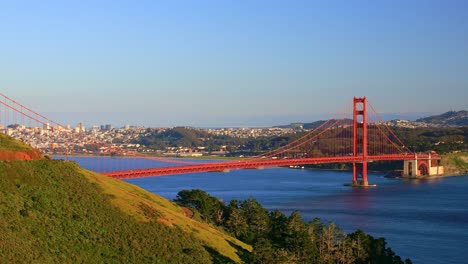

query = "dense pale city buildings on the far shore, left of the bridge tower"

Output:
[[0, 123, 300, 156]]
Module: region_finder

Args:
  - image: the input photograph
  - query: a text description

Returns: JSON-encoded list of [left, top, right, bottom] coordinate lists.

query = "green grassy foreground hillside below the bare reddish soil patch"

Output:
[[0, 157, 251, 263]]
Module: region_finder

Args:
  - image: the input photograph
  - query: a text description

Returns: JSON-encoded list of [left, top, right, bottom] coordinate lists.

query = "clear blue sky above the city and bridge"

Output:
[[0, 0, 468, 126]]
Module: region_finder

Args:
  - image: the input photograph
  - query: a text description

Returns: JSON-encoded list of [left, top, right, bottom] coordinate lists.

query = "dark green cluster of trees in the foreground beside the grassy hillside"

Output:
[[175, 190, 411, 264]]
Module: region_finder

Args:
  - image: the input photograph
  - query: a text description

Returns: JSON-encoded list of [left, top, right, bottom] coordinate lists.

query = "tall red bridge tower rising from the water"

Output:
[[352, 96, 369, 186]]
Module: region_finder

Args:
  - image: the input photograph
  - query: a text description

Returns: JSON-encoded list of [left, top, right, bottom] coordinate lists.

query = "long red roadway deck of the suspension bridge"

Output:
[[103, 154, 428, 179]]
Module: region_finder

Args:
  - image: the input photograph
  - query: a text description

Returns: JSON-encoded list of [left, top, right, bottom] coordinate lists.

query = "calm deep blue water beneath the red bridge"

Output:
[[63, 158, 468, 263]]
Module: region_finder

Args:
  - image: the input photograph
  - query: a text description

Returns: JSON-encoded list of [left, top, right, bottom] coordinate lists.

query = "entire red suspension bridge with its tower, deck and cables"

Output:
[[0, 93, 439, 186]]
